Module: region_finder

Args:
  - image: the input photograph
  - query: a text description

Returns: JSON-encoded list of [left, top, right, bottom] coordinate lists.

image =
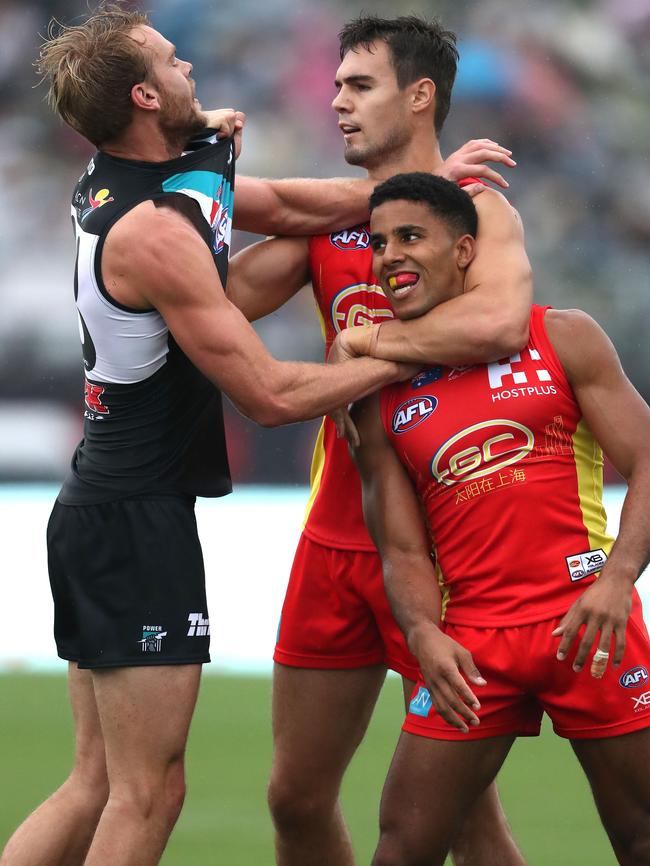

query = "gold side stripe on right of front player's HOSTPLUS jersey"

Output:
[[573, 419, 614, 554]]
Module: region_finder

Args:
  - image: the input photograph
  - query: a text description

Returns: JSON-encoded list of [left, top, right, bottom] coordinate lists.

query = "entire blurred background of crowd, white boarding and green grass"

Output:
[[0, 0, 650, 866]]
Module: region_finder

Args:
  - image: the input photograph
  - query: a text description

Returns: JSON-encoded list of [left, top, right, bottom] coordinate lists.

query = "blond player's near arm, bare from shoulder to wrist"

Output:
[[102, 202, 404, 426]]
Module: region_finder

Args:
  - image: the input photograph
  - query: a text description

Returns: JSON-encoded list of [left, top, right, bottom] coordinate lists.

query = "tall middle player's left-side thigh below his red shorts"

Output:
[[272, 664, 388, 788]]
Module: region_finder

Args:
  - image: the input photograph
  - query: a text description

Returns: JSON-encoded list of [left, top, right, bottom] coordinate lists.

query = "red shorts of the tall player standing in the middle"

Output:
[[273, 534, 418, 680]]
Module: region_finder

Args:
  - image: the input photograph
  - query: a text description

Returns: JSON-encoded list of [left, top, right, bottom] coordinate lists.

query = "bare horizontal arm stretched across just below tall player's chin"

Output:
[[233, 176, 374, 236]]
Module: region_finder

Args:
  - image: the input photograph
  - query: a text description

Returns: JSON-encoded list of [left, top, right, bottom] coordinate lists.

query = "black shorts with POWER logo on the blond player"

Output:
[[47, 496, 210, 668]]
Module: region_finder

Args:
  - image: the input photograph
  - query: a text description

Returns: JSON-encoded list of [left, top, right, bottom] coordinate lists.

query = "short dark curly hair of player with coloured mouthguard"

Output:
[[370, 171, 478, 238]]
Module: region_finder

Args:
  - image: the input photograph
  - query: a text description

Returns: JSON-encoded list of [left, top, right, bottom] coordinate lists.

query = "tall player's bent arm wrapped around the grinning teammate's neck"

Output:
[[339, 189, 533, 365]]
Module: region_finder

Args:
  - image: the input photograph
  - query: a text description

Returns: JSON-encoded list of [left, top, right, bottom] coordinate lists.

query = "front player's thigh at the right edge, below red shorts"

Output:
[[571, 727, 650, 841]]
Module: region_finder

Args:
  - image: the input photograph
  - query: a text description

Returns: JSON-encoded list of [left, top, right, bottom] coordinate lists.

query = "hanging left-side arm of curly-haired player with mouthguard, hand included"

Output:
[[352, 394, 485, 732]]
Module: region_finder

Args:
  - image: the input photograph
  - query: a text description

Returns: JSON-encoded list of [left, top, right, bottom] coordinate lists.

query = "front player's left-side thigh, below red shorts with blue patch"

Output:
[[380, 732, 515, 862]]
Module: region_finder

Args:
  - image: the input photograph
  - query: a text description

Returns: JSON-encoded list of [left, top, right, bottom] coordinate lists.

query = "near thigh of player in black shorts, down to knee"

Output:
[[92, 664, 201, 780]]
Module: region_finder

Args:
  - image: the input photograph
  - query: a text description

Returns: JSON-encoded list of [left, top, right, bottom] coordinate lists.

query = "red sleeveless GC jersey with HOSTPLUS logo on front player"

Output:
[[380, 306, 613, 627]]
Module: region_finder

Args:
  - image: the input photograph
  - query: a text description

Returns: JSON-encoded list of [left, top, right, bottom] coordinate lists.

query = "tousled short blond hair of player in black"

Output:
[[35, 4, 152, 147]]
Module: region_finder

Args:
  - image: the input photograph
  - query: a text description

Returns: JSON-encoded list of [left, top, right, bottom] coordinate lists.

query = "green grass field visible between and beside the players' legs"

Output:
[[0, 674, 615, 866]]
